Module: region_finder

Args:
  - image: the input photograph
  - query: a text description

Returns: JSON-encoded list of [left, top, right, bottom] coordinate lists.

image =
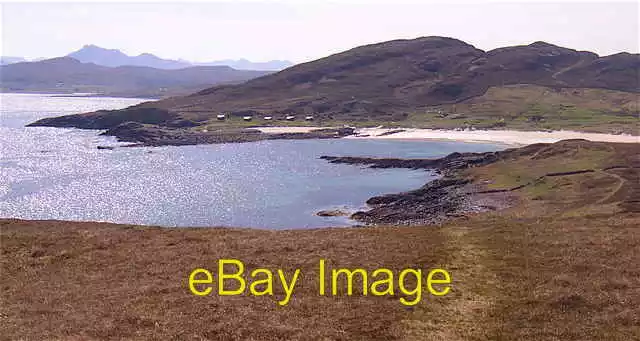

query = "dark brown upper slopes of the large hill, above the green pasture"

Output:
[[151, 37, 640, 116]]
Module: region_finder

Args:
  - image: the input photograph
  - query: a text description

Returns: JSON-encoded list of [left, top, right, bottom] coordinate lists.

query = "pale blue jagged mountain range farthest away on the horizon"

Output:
[[67, 45, 293, 71]]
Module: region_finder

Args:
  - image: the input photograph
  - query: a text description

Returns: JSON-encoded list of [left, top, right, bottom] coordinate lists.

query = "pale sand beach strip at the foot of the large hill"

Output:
[[256, 127, 640, 146]]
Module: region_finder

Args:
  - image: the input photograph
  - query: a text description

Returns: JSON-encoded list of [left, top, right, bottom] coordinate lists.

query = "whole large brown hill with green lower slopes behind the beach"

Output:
[[30, 37, 640, 138]]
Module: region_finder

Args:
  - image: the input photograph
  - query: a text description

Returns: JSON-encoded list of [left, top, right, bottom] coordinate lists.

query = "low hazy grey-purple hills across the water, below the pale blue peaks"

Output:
[[0, 56, 269, 97]]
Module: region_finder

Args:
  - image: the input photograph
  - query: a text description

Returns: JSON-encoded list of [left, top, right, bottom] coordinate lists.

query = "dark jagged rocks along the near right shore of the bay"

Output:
[[320, 140, 556, 225]]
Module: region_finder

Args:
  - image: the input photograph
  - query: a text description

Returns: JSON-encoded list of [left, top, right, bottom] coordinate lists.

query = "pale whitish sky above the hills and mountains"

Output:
[[0, 0, 639, 63]]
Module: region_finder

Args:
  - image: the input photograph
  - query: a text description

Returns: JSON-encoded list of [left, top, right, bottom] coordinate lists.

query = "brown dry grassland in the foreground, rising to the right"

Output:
[[0, 141, 640, 340]]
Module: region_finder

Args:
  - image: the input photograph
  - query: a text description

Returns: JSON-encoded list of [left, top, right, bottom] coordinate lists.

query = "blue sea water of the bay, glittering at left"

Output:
[[0, 94, 500, 229]]
